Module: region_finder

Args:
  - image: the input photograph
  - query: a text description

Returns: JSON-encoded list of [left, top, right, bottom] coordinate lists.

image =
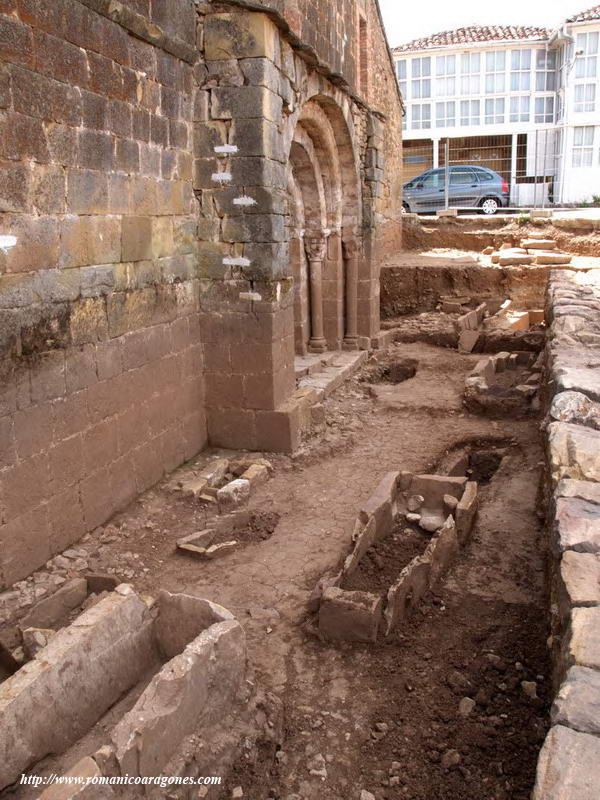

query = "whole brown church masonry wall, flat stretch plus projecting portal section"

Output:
[[0, 0, 401, 587]]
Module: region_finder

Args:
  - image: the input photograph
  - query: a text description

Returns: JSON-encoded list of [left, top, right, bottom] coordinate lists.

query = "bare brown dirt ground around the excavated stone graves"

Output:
[[3, 343, 549, 800]]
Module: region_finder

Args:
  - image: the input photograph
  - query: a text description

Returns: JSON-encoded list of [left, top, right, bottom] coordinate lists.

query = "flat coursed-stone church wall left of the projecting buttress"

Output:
[[0, 0, 206, 586]]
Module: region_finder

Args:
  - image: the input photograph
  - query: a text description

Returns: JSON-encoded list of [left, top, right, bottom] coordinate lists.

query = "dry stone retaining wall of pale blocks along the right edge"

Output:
[[533, 270, 600, 800]]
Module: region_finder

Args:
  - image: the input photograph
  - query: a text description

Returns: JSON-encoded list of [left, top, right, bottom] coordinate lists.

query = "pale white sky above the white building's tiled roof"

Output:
[[379, 0, 595, 47]]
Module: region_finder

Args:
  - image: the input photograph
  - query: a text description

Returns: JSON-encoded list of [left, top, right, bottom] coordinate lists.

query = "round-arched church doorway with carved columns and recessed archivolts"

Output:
[[288, 96, 362, 355]]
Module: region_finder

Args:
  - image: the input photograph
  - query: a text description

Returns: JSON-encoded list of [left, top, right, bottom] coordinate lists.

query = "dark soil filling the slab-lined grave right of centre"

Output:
[[342, 522, 431, 596]]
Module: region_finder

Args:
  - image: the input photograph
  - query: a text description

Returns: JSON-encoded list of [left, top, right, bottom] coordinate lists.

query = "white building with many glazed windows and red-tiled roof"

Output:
[[393, 5, 600, 206]]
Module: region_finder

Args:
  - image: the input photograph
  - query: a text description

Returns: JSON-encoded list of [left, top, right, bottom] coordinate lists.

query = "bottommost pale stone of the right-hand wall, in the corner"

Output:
[[531, 725, 600, 800]]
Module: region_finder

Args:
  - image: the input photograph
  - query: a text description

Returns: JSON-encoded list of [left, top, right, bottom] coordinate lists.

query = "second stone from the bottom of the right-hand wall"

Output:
[[550, 667, 600, 736]]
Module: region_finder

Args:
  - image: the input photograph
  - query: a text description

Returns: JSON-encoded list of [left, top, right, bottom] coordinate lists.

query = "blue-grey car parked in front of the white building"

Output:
[[402, 165, 510, 214]]
